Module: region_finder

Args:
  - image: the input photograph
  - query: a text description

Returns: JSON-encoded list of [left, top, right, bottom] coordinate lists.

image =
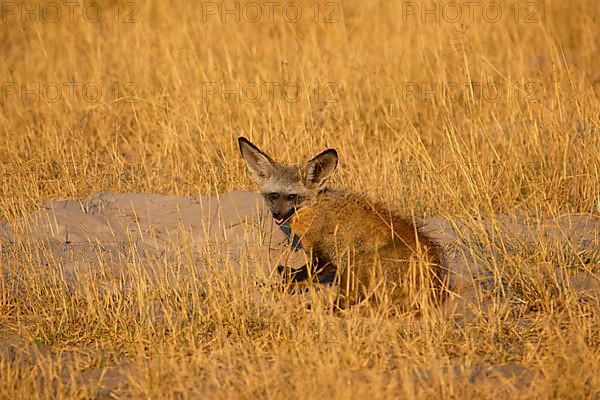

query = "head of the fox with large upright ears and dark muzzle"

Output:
[[238, 137, 338, 225]]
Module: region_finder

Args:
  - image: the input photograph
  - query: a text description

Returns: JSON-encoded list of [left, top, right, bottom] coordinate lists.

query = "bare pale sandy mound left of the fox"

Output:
[[0, 192, 305, 281]]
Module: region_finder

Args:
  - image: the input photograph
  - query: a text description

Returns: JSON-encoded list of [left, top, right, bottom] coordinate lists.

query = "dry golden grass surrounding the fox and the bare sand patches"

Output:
[[0, 0, 600, 398]]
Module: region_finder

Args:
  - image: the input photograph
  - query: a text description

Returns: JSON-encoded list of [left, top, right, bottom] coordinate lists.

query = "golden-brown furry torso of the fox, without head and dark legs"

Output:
[[289, 190, 444, 309]]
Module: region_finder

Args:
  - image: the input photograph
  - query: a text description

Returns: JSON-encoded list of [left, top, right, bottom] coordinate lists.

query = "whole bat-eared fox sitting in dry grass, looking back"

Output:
[[238, 137, 445, 311]]
